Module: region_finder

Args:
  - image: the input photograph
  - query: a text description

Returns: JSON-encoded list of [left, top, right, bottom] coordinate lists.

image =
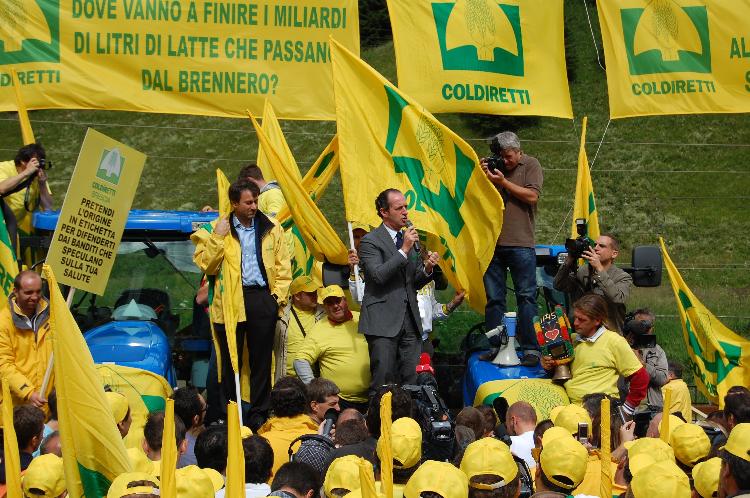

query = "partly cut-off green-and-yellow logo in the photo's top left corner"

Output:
[[0, 0, 60, 65]]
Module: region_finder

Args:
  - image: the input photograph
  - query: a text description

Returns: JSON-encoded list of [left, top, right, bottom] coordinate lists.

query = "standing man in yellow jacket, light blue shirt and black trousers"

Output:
[[192, 181, 292, 430]]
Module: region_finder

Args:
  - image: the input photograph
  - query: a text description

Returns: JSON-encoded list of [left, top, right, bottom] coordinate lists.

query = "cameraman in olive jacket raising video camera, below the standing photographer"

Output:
[[554, 231, 633, 332]]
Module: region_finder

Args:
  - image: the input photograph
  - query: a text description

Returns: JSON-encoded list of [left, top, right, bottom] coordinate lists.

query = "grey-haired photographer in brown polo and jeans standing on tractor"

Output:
[[481, 131, 544, 367]]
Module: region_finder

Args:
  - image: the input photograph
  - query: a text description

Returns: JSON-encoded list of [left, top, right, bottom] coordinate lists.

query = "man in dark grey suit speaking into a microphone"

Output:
[[359, 189, 438, 394]]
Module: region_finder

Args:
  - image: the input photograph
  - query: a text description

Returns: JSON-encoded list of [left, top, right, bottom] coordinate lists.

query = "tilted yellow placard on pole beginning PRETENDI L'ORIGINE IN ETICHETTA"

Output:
[[47, 128, 146, 295]]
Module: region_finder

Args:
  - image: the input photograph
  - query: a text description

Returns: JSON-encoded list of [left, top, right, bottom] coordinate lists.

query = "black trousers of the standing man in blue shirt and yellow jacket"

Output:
[[214, 287, 279, 432]]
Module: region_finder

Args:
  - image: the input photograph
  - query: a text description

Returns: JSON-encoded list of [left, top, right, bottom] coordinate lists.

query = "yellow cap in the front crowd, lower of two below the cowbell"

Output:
[[539, 429, 589, 490]]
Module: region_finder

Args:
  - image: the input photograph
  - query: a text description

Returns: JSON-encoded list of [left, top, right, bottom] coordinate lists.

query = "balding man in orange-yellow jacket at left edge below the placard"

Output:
[[0, 270, 52, 424]]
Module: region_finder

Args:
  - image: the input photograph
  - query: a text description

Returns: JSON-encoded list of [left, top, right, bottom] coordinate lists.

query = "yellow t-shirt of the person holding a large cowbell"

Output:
[[565, 330, 643, 404]]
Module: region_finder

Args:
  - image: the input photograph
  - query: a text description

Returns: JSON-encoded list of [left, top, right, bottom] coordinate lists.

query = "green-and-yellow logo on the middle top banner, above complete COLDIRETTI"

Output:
[[432, 0, 524, 76]]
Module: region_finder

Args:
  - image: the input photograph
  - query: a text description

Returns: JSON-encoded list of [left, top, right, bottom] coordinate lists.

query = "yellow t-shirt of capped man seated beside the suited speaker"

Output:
[[295, 311, 370, 403]]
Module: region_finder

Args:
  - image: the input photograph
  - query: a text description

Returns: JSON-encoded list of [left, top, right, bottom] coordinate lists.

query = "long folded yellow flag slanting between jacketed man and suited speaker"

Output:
[[248, 108, 348, 265]]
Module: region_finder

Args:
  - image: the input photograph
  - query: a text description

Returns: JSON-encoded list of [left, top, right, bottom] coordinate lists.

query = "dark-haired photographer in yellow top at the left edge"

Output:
[[0, 143, 52, 241]]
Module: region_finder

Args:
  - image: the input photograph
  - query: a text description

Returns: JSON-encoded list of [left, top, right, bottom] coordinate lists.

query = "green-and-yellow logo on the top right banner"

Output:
[[620, 0, 711, 75]]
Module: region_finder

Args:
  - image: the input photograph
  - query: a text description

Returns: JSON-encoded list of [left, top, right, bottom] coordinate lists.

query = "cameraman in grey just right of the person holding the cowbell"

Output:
[[623, 308, 669, 410]]
